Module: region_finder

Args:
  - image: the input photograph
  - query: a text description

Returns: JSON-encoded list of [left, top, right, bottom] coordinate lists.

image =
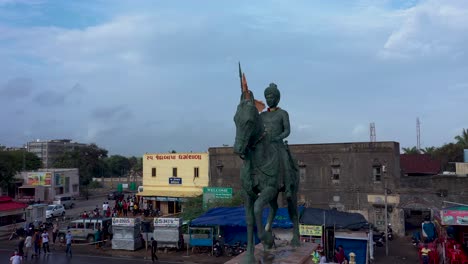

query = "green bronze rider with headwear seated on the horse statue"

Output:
[[260, 83, 296, 198]]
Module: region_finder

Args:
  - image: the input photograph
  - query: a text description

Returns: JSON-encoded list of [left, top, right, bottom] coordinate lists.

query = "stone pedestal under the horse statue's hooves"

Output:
[[224, 242, 317, 264]]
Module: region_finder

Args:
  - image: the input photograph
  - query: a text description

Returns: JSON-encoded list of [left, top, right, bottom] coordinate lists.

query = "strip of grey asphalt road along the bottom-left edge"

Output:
[[0, 249, 183, 264]]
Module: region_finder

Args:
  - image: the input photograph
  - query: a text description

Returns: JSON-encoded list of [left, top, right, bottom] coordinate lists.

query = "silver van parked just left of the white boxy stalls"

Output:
[[58, 217, 112, 243]]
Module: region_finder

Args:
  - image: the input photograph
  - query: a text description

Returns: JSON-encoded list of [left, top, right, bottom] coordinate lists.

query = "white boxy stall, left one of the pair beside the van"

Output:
[[112, 217, 142, 250]]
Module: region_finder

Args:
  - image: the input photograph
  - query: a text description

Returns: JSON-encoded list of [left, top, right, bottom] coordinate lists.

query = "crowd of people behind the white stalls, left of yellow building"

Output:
[[81, 195, 161, 219]]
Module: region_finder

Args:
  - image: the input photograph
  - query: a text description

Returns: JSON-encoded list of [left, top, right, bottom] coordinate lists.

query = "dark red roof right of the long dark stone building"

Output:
[[400, 154, 441, 175]]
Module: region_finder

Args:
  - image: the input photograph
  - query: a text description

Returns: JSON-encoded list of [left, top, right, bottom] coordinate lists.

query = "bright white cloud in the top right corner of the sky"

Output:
[[378, 0, 468, 59]]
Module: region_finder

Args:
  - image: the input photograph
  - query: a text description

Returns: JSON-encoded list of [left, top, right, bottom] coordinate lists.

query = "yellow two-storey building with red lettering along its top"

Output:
[[138, 152, 209, 214]]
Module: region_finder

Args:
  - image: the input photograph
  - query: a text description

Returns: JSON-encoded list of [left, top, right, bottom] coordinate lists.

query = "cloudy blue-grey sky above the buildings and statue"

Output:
[[0, 0, 468, 155]]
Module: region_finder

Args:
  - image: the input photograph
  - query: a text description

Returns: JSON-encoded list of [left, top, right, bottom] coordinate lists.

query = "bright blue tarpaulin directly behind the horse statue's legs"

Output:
[[190, 207, 303, 244]]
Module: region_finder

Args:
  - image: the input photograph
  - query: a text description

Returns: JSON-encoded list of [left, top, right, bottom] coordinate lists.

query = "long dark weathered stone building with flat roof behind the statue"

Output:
[[209, 142, 403, 232]]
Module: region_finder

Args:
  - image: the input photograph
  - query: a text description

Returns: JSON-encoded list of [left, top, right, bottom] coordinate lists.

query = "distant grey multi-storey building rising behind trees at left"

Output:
[[26, 139, 86, 168]]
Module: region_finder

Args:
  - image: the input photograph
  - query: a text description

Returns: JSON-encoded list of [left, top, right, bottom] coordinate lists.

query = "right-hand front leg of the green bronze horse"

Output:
[[254, 187, 278, 250]]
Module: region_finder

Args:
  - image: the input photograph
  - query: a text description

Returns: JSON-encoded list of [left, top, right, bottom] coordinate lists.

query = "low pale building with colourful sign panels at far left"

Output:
[[16, 169, 80, 202]]
